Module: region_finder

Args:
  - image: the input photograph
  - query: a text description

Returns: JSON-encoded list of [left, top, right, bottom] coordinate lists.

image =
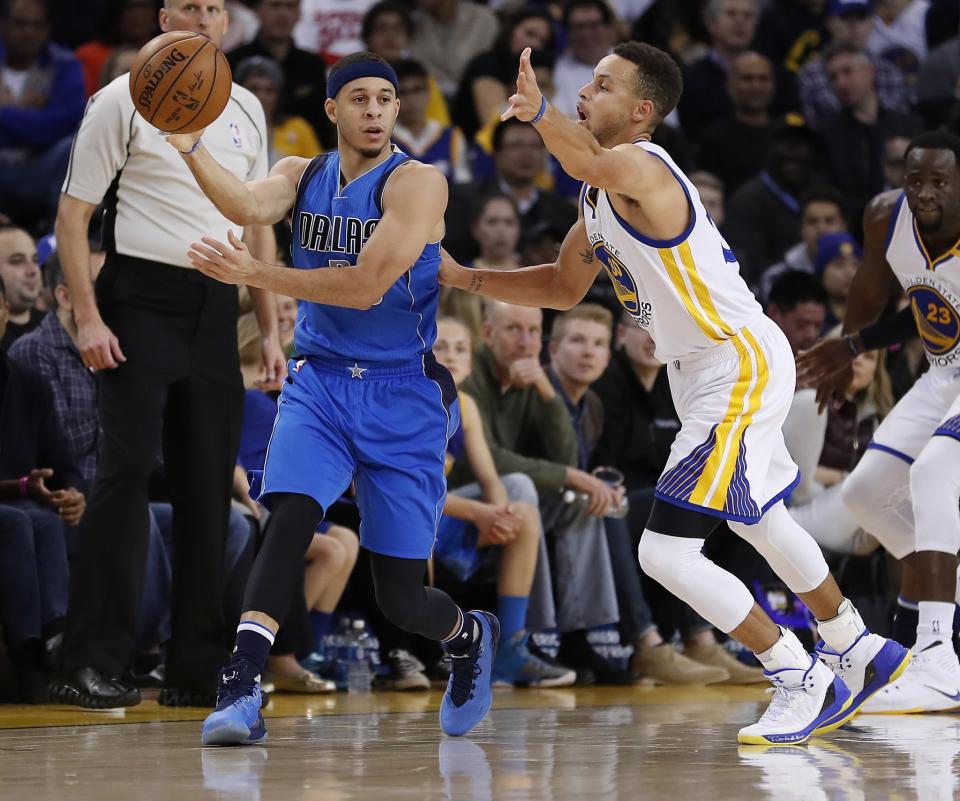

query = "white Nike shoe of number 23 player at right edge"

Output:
[[861, 640, 960, 715]]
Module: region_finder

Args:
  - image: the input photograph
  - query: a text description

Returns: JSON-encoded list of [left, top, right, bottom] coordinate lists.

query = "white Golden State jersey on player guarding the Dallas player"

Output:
[[580, 141, 763, 362]]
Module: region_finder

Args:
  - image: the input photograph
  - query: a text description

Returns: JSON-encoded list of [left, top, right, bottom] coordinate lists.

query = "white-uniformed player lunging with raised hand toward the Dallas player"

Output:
[[441, 42, 910, 744]]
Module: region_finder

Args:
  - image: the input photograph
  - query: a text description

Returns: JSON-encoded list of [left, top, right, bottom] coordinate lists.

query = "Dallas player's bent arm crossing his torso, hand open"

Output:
[[188, 163, 447, 309]]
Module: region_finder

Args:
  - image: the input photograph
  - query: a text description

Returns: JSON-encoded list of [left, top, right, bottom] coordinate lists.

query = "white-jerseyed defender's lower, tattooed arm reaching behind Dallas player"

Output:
[[440, 212, 600, 310]]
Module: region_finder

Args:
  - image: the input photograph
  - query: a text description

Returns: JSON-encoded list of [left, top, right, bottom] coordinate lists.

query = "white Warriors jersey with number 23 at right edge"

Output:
[[885, 192, 960, 370]]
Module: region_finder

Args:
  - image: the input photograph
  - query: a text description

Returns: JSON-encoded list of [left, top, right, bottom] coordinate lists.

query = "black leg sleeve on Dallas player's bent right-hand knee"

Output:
[[370, 553, 460, 641]]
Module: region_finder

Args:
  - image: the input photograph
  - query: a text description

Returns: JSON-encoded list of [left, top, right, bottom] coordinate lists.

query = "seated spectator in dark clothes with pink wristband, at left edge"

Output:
[[0, 280, 86, 703]]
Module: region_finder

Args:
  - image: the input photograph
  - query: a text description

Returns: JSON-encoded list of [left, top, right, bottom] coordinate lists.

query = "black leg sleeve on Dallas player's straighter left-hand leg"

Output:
[[243, 492, 323, 623]]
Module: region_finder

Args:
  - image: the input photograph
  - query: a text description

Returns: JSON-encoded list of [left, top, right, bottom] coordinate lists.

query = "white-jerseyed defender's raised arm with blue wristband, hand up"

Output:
[[502, 48, 672, 200]]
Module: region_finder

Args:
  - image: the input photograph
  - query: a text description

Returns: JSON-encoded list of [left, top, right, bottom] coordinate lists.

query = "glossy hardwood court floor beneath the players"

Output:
[[0, 688, 960, 801]]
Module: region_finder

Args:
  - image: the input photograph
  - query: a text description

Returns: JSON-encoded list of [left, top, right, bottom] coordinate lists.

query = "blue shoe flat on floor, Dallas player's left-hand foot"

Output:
[[200, 662, 267, 745]]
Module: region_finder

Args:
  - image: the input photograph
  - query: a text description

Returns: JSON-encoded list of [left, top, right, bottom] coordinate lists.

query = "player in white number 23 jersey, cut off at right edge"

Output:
[[799, 131, 960, 712]]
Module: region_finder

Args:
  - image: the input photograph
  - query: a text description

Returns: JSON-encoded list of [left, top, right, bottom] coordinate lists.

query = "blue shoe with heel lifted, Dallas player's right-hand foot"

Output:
[[440, 611, 500, 737]]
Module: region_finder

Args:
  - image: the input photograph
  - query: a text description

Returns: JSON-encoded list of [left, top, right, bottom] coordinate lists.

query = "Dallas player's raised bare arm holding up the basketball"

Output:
[[167, 132, 310, 226]]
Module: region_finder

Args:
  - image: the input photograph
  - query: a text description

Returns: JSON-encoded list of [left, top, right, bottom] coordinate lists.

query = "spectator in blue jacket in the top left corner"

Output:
[[0, 0, 85, 230]]
